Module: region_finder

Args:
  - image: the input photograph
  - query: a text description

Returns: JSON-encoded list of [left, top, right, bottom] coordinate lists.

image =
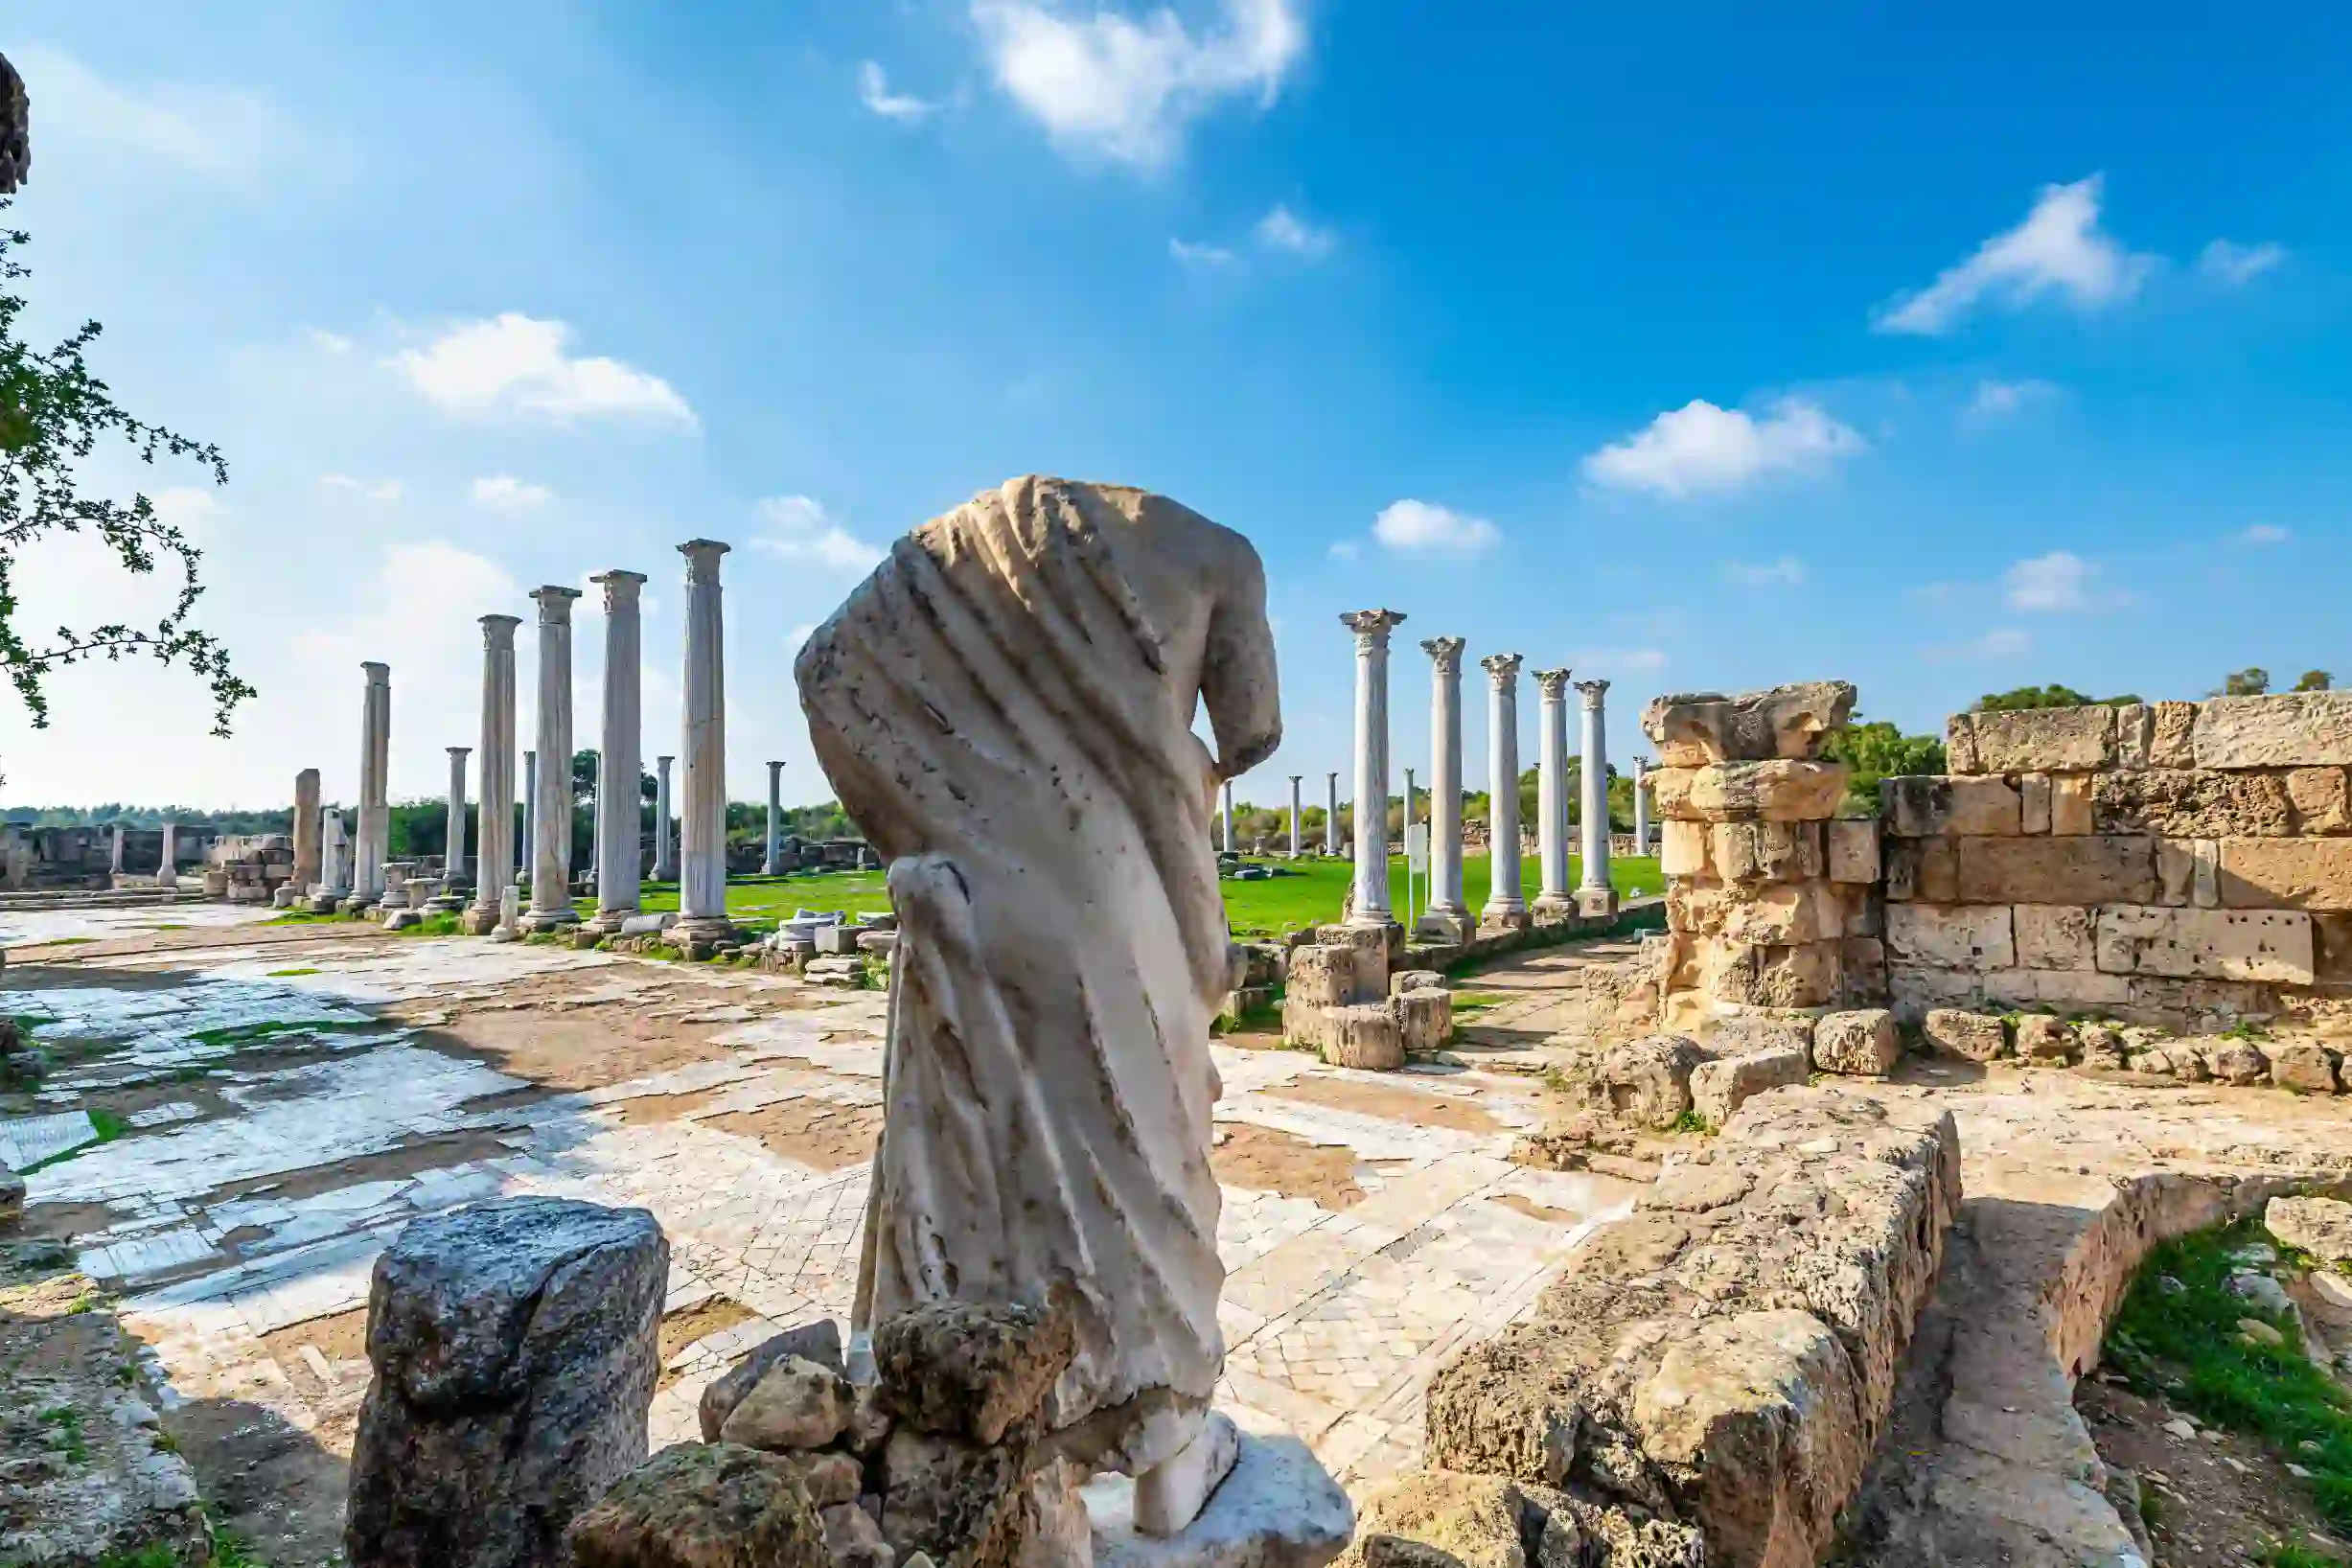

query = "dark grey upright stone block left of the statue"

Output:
[[343, 1196, 670, 1568]]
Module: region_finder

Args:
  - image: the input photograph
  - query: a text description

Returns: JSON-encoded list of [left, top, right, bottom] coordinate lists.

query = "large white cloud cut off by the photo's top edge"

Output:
[[972, 0, 1307, 167]]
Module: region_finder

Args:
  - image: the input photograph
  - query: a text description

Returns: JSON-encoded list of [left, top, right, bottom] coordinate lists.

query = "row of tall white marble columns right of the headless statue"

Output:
[[1345, 609, 1649, 940]]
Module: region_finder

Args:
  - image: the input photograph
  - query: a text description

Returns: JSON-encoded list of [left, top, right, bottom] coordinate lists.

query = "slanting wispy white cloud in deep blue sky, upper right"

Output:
[[1872, 174, 2155, 336]]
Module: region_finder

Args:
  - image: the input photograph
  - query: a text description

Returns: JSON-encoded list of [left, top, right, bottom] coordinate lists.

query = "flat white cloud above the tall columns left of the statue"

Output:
[[390, 311, 696, 430]]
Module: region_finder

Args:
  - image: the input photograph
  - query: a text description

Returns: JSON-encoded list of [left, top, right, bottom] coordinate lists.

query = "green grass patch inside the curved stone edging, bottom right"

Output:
[[2105, 1220, 2352, 1533]]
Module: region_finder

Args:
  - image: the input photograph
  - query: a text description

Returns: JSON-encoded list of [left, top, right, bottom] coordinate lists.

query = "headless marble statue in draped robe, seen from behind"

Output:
[[795, 477, 1281, 1471]]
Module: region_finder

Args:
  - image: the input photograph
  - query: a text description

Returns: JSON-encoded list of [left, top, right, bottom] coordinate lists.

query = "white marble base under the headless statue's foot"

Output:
[[1079, 1432, 1355, 1568]]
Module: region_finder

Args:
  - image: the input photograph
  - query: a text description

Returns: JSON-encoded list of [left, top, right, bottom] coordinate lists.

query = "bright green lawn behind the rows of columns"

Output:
[[597, 856, 1665, 935]]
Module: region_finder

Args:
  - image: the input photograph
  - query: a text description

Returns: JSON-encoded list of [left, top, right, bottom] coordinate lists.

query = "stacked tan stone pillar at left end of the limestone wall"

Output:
[[1642, 681, 1884, 1029]]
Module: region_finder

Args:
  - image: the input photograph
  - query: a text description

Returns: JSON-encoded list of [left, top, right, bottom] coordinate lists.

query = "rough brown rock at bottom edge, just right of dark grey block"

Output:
[[566, 1443, 833, 1568]]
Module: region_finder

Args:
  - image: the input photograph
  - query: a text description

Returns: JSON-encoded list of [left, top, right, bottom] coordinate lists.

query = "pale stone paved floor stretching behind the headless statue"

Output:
[[0, 926, 1632, 1488]]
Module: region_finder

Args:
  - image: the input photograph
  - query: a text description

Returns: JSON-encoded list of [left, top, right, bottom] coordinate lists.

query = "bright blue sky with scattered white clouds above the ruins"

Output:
[[0, 0, 2352, 804]]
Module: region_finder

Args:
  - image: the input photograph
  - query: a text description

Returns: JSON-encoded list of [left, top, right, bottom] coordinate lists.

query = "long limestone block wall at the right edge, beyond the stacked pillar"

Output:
[[1881, 691, 2352, 1029]]
